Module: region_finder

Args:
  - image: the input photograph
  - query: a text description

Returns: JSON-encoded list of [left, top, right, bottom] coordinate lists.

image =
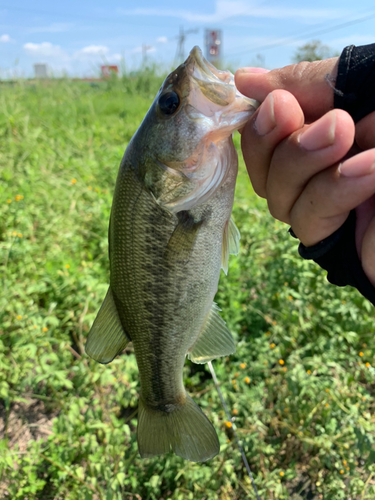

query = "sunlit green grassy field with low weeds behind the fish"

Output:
[[0, 73, 375, 500]]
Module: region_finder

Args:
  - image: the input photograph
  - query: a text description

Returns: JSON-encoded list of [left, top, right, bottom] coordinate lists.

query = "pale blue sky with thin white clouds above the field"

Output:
[[0, 0, 375, 78]]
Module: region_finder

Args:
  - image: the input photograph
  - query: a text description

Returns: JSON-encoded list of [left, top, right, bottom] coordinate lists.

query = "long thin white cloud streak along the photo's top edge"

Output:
[[120, 0, 345, 23]]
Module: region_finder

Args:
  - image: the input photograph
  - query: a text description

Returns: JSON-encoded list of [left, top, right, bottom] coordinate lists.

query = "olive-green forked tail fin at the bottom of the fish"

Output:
[[137, 395, 220, 462]]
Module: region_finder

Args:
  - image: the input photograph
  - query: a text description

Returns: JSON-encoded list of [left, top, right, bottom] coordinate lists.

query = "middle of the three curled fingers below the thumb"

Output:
[[266, 109, 354, 225]]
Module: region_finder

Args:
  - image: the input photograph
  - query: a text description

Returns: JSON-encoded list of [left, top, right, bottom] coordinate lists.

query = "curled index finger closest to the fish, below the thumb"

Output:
[[241, 90, 303, 198]]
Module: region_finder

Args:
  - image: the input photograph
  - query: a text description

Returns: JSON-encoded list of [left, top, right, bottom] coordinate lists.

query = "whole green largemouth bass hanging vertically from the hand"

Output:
[[86, 47, 258, 462]]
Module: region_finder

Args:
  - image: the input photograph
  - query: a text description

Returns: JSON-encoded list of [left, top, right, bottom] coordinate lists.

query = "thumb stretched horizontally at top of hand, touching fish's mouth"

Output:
[[235, 57, 338, 122]]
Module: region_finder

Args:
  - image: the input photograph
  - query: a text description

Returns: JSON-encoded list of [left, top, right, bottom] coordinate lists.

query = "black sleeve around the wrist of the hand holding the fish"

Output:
[[291, 44, 375, 305]]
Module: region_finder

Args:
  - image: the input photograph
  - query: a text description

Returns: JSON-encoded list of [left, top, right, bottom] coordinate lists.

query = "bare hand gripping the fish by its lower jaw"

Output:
[[236, 58, 375, 285]]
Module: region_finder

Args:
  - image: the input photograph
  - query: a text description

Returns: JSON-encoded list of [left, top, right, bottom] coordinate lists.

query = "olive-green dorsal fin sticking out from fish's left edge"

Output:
[[85, 287, 130, 364]]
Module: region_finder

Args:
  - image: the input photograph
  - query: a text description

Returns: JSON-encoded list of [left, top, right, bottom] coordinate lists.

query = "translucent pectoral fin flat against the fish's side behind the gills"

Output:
[[164, 211, 202, 261]]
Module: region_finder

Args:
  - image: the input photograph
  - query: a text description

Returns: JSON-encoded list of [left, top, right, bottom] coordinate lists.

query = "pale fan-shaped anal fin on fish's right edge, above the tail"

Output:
[[188, 302, 236, 364]]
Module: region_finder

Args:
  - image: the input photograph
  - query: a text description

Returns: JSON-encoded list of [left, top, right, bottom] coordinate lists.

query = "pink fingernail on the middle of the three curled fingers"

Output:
[[298, 111, 336, 151]]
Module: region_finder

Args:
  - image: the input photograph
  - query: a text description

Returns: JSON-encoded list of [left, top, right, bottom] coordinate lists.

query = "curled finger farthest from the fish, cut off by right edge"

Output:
[[290, 149, 375, 246]]
